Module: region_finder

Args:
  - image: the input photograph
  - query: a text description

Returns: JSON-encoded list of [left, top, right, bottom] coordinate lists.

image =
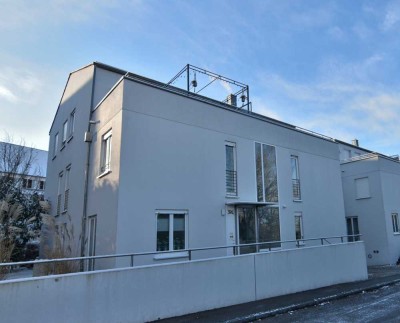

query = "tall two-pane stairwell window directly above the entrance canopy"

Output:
[[255, 143, 278, 202]]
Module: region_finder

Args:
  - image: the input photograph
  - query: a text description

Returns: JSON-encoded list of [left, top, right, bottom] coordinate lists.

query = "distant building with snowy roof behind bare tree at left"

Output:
[[0, 142, 47, 198]]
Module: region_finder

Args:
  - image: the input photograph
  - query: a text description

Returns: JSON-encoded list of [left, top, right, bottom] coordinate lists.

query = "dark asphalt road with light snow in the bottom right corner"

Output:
[[262, 284, 400, 323]]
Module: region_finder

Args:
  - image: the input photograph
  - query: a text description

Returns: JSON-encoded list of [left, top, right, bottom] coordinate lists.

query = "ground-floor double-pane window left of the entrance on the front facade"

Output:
[[157, 211, 187, 251]]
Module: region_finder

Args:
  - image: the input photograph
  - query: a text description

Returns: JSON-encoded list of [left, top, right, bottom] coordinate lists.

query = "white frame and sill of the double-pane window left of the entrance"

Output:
[[154, 210, 189, 260]]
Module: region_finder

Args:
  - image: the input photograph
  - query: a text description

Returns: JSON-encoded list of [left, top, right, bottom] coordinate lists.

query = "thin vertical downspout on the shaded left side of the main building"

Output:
[[80, 65, 96, 264]]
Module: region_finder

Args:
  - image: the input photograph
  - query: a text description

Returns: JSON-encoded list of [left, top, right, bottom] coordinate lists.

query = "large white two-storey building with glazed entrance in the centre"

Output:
[[46, 63, 346, 268]]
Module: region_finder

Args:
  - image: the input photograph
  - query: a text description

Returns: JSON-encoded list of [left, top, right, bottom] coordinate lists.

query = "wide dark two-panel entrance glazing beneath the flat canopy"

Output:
[[237, 206, 281, 254]]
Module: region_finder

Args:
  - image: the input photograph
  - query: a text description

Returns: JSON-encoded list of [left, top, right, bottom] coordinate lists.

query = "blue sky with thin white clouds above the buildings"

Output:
[[0, 0, 400, 155]]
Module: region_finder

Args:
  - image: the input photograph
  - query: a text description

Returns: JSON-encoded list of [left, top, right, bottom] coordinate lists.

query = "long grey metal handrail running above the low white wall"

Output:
[[0, 234, 362, 267]]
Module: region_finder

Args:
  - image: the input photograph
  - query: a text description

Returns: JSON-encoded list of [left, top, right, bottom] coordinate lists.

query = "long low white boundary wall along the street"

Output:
[[0, 242, 368, 323]]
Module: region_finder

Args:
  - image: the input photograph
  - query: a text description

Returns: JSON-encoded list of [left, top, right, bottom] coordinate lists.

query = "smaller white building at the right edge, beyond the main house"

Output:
[[337, 141, 400, 265]]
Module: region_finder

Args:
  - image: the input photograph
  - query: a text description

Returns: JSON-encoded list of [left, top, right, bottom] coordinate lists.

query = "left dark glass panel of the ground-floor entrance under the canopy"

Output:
[[238, 208, 256, 254]]
